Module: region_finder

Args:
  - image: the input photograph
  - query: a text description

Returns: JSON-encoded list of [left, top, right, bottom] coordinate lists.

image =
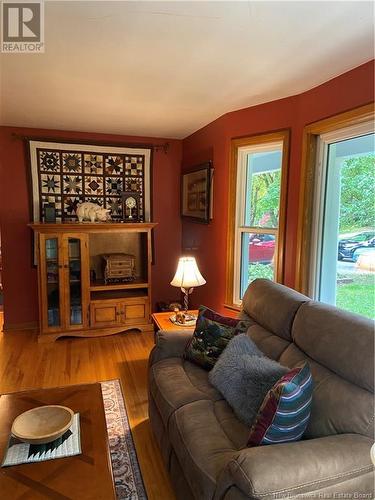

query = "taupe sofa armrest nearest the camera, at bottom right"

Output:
[[215, 434, 374, 500]]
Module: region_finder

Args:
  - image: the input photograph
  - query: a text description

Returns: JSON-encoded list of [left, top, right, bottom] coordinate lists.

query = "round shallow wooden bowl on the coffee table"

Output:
[[11, 405, 74, 444]]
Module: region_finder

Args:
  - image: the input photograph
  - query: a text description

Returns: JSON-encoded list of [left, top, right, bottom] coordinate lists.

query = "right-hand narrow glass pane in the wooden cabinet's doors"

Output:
[[68, 237, 83, 326]]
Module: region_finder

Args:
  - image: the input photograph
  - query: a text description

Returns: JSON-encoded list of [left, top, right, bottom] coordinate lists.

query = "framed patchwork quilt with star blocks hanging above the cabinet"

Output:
[[28, 140, 151, 222]]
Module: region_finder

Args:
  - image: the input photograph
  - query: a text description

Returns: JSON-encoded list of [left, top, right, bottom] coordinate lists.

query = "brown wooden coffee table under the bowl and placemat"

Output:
[[0, 384, 116, 500]]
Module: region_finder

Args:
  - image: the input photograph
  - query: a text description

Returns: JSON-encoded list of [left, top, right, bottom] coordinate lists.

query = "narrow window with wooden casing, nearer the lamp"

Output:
[[227, 132, 288, 306]]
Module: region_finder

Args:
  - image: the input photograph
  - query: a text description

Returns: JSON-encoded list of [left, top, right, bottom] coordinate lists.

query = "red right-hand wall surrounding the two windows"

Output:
[[182, 61, 374, 310]]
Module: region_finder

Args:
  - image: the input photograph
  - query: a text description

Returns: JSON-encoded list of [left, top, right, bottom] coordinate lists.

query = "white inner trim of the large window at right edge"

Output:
[[308, 120, 374, 300]]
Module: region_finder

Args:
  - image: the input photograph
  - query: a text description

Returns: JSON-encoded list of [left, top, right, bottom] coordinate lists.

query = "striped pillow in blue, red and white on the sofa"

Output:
[[247, 363, 313, 446]]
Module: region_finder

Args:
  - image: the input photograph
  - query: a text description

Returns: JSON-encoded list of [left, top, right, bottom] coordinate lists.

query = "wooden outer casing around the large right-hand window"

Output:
[[294, 103, 375, 296]]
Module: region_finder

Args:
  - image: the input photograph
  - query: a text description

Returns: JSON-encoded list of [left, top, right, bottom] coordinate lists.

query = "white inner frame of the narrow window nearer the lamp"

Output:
[[233, 141, 284, 306]]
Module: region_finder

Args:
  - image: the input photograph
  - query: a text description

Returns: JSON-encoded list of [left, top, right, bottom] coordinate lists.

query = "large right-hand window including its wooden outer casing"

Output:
[[295, 104, 375, 318]]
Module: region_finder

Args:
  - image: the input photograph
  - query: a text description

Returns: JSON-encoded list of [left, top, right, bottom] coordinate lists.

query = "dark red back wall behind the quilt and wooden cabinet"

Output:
[[0, 127, 182, 325]]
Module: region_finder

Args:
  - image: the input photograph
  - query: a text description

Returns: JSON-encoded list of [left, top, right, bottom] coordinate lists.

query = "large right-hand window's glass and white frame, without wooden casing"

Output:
[[309, 122, 375, 318]]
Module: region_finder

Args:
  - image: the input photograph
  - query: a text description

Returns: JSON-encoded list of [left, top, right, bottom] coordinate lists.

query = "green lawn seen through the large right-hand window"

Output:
[[336, 273, 375, 319]]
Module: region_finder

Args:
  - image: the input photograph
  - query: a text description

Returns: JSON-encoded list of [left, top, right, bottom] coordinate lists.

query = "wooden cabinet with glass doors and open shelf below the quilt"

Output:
[[31, 223, 155, 341]]
